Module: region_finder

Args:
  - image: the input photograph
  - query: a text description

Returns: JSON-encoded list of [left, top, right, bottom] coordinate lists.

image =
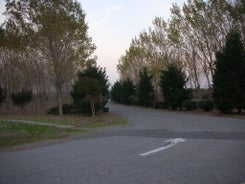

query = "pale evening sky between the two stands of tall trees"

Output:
[[0, 0, 187, 85]]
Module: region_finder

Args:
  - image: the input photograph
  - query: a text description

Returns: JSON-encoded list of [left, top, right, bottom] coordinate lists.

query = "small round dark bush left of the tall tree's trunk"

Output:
[[11, 91, 32, 109]]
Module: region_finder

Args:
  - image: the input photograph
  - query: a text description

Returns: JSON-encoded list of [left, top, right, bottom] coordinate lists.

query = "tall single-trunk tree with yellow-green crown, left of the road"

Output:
[[6, 0, 95, 115]]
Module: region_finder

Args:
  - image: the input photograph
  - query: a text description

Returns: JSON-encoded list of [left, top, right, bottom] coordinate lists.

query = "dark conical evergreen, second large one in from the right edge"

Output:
[[159, 65, 192, 110]]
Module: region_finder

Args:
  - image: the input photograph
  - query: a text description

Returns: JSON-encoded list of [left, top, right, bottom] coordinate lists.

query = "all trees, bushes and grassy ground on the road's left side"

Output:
[[0, 0, 127, 149]]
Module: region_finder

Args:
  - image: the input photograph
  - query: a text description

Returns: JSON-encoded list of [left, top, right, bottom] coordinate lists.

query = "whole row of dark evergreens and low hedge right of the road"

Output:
[[111, 31, 245, 113]]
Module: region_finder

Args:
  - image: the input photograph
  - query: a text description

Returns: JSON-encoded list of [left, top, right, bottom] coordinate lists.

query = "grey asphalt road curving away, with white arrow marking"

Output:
[[0, 105, 245, 184]]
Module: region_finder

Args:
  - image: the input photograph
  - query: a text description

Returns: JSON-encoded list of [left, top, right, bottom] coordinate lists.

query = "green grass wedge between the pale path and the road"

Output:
[[0, 121, 84, 147]]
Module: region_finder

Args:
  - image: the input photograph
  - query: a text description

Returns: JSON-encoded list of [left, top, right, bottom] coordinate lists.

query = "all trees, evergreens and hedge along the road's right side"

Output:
[[111, 0, 245, 113]]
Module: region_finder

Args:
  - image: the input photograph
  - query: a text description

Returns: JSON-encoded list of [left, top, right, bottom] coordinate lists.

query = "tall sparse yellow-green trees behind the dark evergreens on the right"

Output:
[[117, 0, 245, 89]]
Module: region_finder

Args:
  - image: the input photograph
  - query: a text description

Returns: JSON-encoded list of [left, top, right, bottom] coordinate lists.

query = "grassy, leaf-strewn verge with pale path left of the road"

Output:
[[0, 113, 127, 148]]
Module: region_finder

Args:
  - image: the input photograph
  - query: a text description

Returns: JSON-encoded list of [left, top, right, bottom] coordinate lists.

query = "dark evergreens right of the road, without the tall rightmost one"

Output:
[[111, 64, 192, 110]]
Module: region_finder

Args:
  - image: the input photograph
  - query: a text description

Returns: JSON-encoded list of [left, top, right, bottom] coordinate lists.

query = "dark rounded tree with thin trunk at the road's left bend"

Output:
[[71, 66, 109, 114]]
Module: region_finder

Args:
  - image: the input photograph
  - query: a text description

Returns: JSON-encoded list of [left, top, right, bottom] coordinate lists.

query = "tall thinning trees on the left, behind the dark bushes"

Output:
[[0, 0, 104, 115]]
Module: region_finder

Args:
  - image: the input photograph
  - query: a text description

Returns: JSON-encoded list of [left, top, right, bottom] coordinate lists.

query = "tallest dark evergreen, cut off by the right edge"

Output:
[[213, 32, 245, 113]]
